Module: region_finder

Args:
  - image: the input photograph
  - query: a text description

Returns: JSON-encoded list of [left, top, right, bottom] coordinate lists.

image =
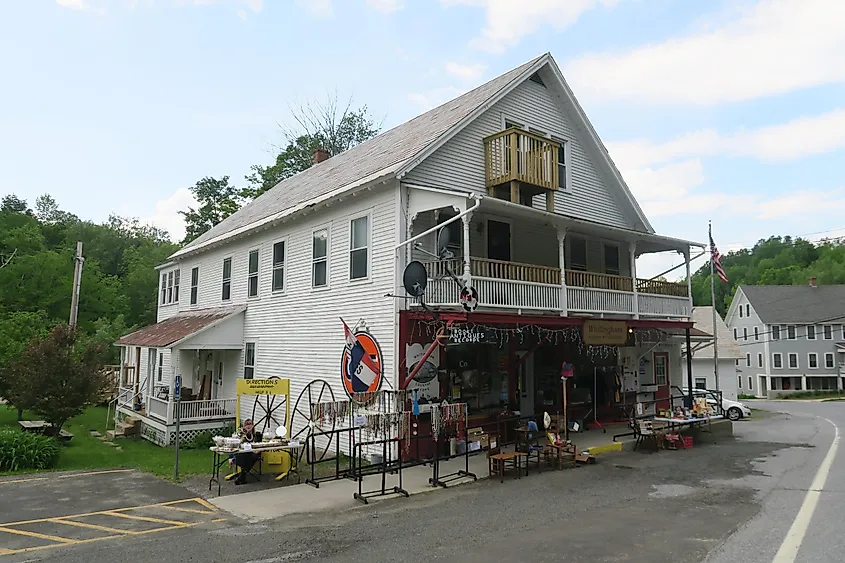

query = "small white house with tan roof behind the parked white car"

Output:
[[683, 307, 745, 401]]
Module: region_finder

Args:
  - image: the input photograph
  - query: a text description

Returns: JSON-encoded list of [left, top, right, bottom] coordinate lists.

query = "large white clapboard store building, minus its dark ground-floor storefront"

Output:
[[117, 54, 703, 450]]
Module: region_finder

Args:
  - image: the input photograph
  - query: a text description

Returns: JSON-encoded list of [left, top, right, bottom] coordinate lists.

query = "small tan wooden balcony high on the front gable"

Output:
[[484, 128, 560, 190]]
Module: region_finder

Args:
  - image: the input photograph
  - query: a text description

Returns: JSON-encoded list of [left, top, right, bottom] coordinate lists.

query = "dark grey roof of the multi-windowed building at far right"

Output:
[[734, 285, 845, 324]]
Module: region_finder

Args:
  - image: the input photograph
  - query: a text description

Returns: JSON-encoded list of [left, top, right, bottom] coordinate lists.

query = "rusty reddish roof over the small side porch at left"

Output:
[[115, 307, 246, 348]]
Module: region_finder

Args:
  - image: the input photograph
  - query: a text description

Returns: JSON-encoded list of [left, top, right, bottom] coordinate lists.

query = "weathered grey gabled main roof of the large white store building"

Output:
[[171, 53, 654, 258]]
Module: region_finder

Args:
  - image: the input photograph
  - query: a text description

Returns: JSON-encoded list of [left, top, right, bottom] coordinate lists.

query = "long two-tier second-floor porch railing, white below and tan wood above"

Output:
[[418, 258, 691, 317]]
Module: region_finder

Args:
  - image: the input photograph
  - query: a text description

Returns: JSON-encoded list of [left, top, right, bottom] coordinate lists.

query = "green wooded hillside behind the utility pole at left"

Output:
[[0, 195, 177, 364]]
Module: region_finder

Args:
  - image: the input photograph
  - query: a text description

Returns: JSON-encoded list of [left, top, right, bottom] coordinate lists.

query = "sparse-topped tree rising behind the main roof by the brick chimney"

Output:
[[242, 96, 381, 199]]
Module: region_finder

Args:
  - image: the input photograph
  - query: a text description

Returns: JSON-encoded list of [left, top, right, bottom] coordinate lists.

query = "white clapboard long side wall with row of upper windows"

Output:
[[170, 184, 398, 440]]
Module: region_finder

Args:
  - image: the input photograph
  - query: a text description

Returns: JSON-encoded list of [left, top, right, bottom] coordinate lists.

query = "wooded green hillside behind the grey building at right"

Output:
[[692, 236, 845, 316]]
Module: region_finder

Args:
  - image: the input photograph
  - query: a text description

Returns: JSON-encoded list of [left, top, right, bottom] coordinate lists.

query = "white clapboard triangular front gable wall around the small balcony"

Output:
[[406, 80, 635, 228]]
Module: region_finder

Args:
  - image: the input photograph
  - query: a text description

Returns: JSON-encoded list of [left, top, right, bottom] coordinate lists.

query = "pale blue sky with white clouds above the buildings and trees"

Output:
[[0, 0, 845, 278]]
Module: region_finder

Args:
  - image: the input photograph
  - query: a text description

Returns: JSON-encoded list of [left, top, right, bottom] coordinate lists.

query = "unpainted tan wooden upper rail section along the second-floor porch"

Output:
[[425, 257, 687, 297]]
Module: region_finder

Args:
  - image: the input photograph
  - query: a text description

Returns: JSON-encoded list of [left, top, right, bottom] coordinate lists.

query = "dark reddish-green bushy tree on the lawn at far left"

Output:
[[7, 325, 106, 433]]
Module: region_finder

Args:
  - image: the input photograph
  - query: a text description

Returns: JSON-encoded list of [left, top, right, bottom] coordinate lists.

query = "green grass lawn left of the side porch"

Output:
[[0, 405, 211, 479]]
